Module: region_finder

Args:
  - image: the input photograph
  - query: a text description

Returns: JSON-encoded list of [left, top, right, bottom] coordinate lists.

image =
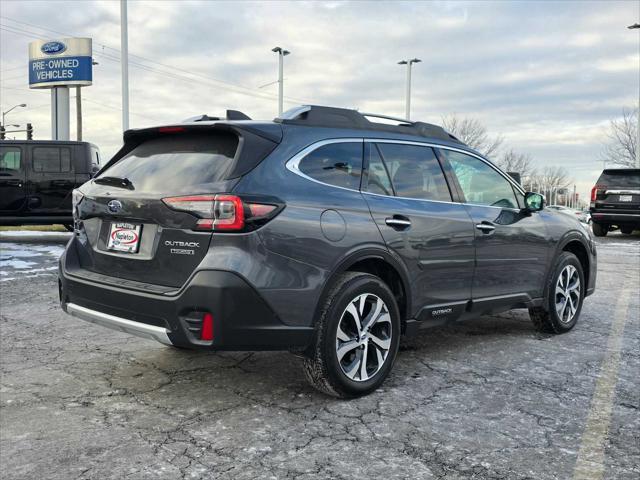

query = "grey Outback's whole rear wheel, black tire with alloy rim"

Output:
[[303, 272, 400, 398]]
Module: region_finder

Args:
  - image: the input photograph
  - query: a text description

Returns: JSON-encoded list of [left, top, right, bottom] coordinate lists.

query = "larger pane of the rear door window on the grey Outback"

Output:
[[377, 143, 451, 202]]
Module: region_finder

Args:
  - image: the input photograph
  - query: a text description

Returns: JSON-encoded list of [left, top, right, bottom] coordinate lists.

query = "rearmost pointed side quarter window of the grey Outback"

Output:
[[298, 142, 362, 190]]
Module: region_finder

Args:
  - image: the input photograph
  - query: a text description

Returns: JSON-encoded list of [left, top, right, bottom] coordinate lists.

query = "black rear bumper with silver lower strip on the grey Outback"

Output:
[[58, 254, 313, 350]]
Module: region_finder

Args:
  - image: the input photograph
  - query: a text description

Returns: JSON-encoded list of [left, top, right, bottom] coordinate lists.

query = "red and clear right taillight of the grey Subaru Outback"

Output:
[[162, 193, 281, 232]]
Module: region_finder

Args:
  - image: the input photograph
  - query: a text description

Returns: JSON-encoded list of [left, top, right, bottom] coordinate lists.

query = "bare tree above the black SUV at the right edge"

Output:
[[602, 108, 638, 167]]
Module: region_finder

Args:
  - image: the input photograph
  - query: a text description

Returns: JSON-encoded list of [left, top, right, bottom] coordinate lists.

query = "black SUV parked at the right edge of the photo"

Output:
[[589, 168, 640, 237]]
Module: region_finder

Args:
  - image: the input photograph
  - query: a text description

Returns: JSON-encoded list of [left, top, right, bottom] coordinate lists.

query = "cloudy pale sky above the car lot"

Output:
[[0, 0, 640, 199]]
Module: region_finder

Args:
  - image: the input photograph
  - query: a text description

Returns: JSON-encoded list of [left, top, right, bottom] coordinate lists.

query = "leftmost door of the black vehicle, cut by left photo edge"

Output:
[[0, 145, 26, 215]]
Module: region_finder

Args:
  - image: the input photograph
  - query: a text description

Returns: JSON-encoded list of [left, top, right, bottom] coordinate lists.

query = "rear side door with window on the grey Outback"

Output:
[[362, 141, 474, 323]]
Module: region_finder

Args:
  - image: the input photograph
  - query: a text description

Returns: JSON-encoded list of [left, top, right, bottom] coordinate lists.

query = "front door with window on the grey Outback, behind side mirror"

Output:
[[438, 148, 550, 311]]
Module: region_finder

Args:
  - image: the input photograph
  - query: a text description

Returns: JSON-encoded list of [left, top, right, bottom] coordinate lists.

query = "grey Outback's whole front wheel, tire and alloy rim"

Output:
[[529, 252, 587, 333]]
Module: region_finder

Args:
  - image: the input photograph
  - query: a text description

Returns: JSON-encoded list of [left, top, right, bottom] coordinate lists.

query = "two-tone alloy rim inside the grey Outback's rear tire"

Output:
[[336, 293, 393, 382]]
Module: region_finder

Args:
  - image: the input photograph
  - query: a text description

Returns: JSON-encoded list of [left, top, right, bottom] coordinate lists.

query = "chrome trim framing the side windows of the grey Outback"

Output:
[[285, 137, 526, 212]]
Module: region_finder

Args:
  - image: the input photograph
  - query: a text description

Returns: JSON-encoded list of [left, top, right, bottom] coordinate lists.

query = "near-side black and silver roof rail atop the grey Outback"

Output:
[[274, 105, 462, 144]]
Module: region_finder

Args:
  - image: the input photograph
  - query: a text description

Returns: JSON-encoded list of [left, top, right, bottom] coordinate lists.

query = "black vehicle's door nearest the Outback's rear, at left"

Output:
[[27, 145, 75, 215]]
